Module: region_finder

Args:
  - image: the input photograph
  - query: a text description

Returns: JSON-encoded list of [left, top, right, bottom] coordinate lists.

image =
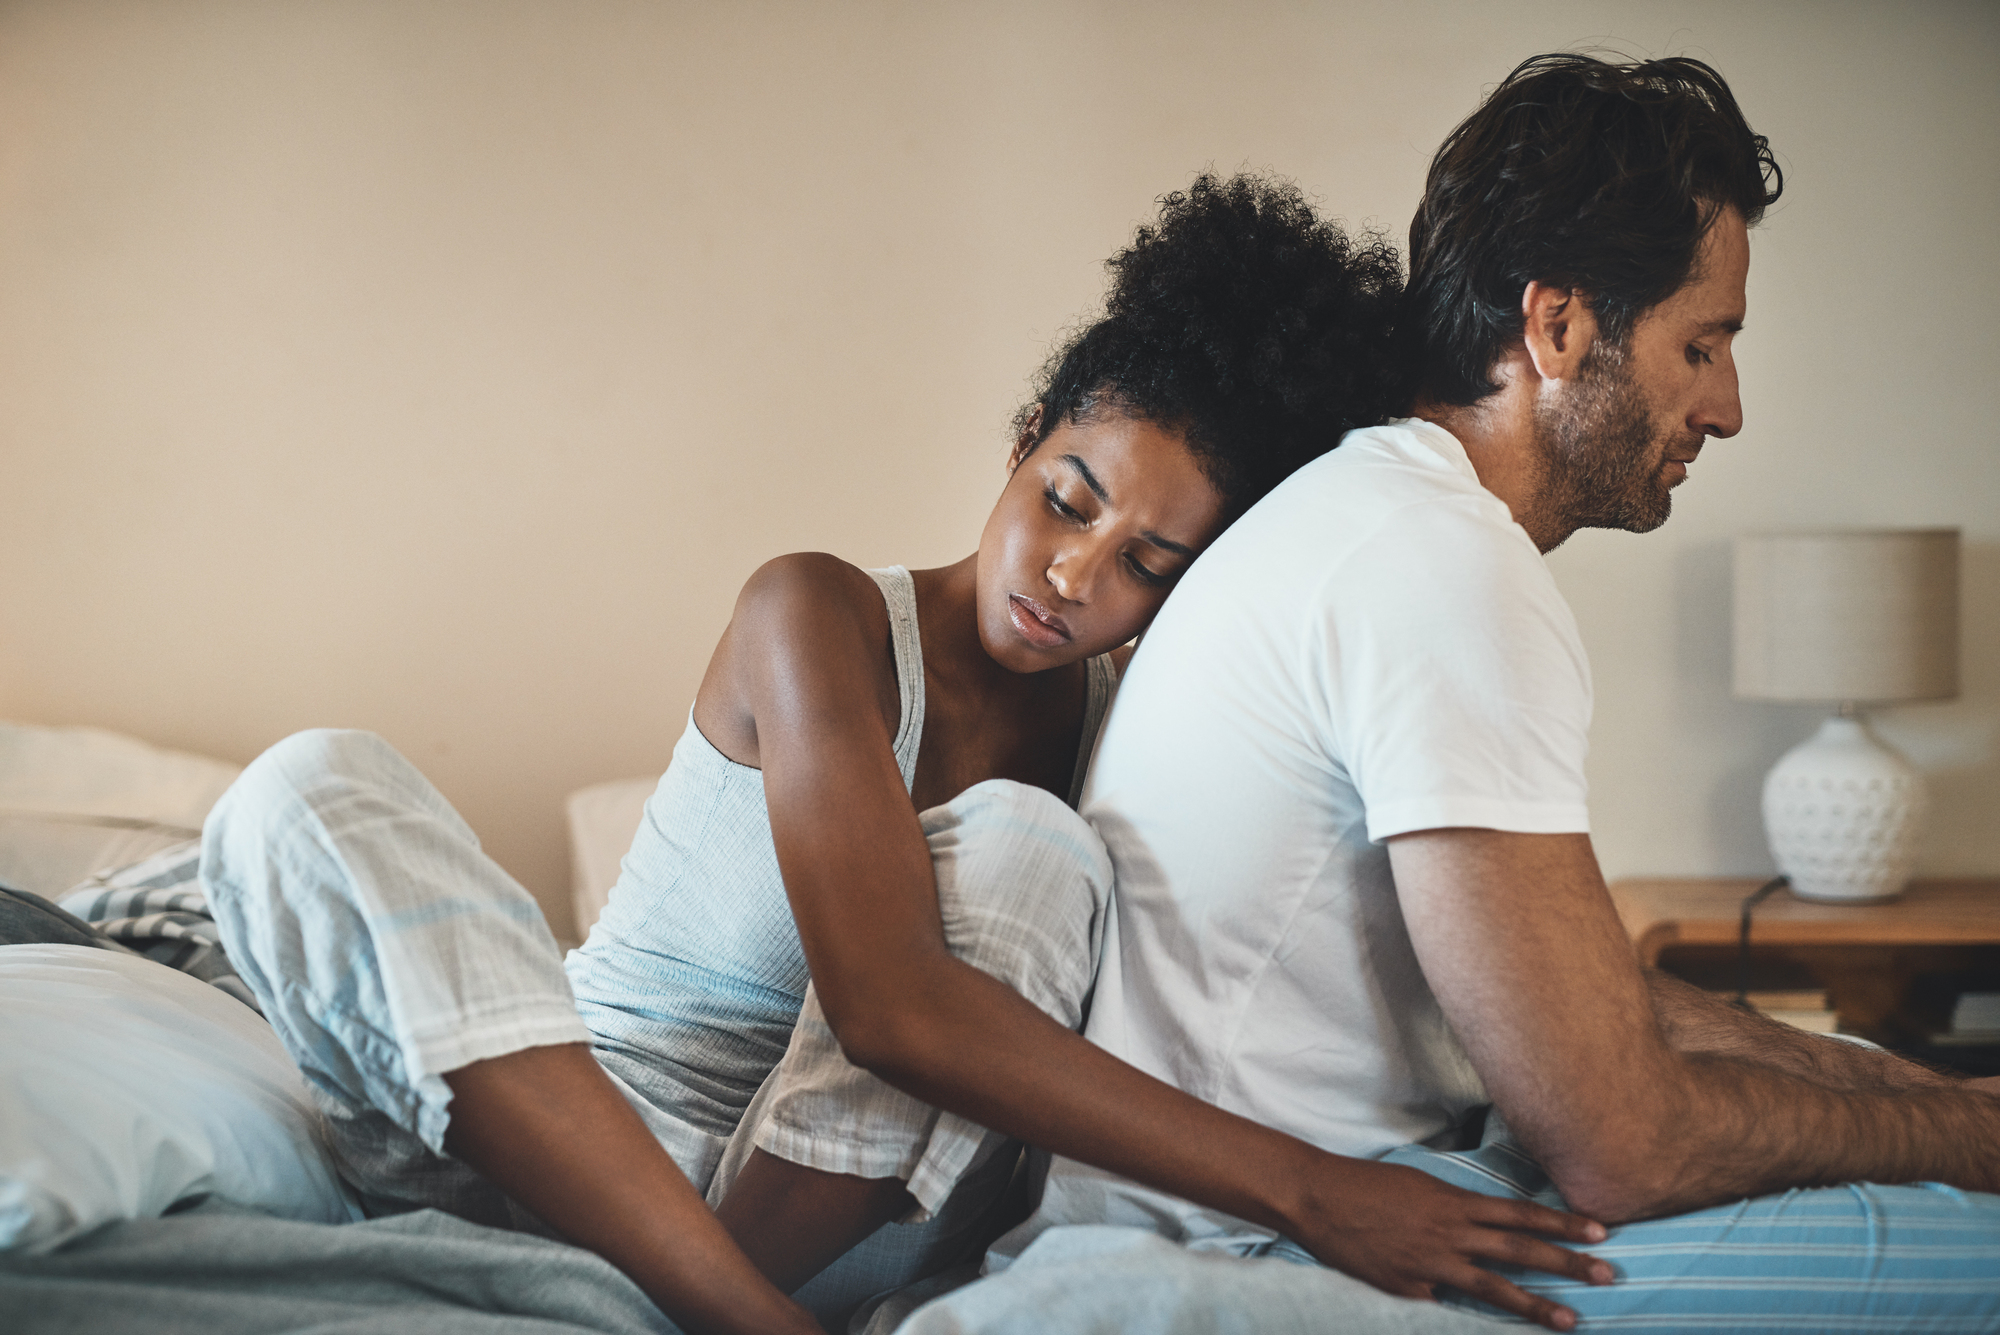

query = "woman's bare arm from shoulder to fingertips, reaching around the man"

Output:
[[716, 558, 1608, 1329]]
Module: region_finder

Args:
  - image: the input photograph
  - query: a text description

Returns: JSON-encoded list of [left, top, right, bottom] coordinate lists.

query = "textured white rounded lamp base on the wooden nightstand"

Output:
[[1764, 717, 1928, 903]]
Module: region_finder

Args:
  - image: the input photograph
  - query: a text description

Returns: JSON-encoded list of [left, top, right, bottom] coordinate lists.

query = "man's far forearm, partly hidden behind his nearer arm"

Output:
[[1646, 969, 1960, 1093]]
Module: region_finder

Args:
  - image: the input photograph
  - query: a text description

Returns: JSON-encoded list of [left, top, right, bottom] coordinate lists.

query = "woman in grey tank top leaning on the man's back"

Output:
[[204, 176, 1598, 1329]]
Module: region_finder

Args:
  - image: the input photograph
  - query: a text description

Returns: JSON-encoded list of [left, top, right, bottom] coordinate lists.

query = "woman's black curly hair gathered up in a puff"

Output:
[[1014, 172, 1410, 520]]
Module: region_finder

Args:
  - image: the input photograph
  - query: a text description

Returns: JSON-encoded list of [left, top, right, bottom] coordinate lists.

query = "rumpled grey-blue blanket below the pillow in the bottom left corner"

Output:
[[0, 1201, 678, 1335]]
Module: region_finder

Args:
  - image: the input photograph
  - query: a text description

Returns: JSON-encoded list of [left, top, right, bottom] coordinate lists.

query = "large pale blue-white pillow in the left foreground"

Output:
[[0, 945, 362, 1253]]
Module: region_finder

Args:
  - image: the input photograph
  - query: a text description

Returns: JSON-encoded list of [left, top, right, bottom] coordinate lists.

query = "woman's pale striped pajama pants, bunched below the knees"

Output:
[[202, 729, 1110, 1319]]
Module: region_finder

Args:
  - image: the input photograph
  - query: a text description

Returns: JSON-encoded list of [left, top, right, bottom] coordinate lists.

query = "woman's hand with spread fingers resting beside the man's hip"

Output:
[[1286, 1157, 1612, 1331]]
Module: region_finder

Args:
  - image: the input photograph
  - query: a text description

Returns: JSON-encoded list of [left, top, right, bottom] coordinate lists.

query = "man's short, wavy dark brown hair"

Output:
[[1404, 54, 1784, 404]]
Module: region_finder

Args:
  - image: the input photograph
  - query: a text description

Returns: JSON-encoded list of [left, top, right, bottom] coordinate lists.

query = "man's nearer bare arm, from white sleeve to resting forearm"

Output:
[[1390, 829, 2000, 1221]]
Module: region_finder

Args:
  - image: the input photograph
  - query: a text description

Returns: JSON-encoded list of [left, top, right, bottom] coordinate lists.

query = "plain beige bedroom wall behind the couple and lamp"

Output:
[[0, 0, 2000, 927]]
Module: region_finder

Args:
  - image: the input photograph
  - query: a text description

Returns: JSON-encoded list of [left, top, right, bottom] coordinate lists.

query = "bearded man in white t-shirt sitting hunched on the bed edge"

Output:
[[998, 56, 2000, 1329]]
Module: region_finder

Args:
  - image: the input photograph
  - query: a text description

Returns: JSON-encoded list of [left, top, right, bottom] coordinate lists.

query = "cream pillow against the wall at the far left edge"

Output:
[[0, 723, 242, 899]]
